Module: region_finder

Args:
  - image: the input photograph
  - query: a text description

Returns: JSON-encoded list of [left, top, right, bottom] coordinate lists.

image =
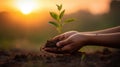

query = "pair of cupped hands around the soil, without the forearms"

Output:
[[45, 32, 89, 53]]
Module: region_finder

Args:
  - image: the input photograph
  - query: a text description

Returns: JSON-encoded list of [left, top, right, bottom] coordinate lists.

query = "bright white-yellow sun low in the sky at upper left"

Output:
[[16, 0, 38, 14]]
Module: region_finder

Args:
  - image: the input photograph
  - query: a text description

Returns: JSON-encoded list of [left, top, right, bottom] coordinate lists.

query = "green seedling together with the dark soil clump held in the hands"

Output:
[[45, 4, 74, 54]]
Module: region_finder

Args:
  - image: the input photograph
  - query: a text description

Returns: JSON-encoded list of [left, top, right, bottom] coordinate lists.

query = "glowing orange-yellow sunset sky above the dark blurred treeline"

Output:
[[0, 0, 111, 26]]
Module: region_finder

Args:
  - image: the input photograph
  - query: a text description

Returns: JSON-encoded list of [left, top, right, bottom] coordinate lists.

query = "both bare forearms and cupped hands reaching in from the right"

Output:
[[44, 26, 120, 52]]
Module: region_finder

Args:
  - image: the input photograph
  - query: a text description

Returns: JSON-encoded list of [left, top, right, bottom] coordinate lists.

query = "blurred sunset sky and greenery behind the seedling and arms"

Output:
[[0, 0, 120, 51]]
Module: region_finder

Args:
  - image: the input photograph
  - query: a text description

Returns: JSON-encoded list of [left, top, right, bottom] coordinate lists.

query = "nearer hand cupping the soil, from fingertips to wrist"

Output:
[[57, 33, 89, 53]]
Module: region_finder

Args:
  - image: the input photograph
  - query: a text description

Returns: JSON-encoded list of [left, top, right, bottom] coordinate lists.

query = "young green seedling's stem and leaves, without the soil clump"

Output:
[[49, 4, 74, 33]]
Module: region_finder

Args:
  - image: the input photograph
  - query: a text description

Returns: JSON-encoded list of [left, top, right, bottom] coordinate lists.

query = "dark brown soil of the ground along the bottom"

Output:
[[0, 48, 120, 67]]
